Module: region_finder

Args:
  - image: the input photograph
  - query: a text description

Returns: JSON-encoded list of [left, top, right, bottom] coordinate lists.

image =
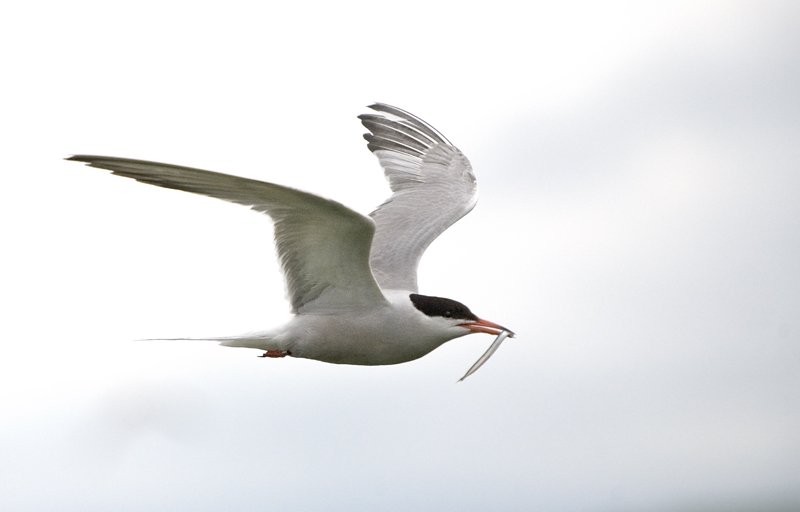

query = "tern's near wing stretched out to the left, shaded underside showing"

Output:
[[68, 155, 386, 313]]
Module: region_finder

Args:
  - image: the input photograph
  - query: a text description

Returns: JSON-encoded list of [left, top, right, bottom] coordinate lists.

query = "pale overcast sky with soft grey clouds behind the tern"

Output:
[[0, 1, 800, 512]]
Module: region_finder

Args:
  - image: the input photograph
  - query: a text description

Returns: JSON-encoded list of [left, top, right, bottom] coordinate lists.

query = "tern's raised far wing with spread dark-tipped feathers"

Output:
[[359, 103, 477, 291]]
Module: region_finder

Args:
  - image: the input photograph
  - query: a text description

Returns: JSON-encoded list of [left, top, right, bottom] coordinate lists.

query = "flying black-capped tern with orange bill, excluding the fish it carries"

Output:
[[72, 103, 513, 371]]
